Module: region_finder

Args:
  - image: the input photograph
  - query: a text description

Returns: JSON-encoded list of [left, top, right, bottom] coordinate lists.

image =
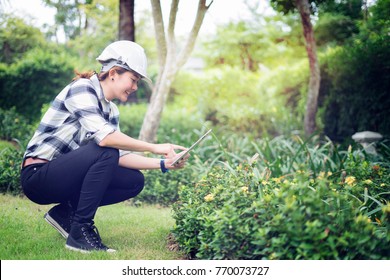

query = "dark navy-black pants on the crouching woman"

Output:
[[21, 143, 144, 223]]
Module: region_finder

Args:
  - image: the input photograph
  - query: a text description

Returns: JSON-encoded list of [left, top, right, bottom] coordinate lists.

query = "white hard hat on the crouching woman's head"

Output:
[[96, 40, 150, 81]]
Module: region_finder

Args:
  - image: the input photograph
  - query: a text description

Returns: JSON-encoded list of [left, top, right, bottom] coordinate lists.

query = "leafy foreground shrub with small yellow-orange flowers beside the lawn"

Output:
[[173, 164, 390, 259]]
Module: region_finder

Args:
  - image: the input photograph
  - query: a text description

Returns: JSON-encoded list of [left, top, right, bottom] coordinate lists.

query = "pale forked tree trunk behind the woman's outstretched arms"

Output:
[[139, 0, 212, 142]]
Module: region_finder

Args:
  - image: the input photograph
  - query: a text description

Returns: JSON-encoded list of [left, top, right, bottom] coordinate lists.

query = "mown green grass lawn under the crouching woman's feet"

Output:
[[0, 195, 184, 260]]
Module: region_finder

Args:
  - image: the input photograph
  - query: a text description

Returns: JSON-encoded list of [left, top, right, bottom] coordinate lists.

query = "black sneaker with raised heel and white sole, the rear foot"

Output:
[[43, 204, 73, 239]]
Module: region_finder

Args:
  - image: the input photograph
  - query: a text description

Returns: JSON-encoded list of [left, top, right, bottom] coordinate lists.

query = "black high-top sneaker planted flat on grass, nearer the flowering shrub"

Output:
[[65, 223, 116, 253]]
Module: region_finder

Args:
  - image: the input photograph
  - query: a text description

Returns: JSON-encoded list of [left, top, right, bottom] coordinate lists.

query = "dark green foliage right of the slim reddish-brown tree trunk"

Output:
[[321, 0, 390, 141]]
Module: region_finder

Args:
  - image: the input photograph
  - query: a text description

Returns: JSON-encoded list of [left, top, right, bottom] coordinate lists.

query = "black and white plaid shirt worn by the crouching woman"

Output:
[[24, 75, 129, 160]]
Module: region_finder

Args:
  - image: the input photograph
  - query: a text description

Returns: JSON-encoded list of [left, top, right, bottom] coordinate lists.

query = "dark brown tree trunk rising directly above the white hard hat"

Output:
[[118, 0, 135, 42]]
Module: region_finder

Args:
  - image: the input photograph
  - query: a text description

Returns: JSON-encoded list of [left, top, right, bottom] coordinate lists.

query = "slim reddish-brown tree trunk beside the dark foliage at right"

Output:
[[295, 0, 321, 136]]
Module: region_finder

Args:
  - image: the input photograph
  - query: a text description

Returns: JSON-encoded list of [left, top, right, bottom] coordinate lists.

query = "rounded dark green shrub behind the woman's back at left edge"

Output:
[[0, 47, 73, 121]]
